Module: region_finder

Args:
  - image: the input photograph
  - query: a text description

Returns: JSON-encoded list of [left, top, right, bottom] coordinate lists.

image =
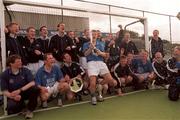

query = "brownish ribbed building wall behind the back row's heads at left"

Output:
[[5, 11, 89, 31]]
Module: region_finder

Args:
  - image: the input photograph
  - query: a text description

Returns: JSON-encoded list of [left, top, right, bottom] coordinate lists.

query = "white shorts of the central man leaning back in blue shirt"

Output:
[[88, 61, 109, 76]]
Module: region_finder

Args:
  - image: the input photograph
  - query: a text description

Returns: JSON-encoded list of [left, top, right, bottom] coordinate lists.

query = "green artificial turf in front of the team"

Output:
[[1, 90, 180, 120]]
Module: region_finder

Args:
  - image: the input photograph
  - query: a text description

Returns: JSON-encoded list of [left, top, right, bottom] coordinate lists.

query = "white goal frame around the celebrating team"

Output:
[[0, 0, 149, 115]]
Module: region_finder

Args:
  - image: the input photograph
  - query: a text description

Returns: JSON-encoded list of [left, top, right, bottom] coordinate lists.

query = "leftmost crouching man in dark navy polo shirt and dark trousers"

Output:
[[1, 55, 39, 118]]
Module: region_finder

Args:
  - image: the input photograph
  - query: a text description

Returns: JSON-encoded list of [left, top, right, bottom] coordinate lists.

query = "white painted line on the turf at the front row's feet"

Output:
[[0, 90, 146, 120]]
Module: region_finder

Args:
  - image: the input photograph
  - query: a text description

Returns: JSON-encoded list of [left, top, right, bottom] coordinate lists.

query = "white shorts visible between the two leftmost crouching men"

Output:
[[26, 60, 44, 76]]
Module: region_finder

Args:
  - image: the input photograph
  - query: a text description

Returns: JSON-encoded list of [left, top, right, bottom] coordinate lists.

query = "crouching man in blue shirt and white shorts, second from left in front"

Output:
[[35, 53, 71, 108]]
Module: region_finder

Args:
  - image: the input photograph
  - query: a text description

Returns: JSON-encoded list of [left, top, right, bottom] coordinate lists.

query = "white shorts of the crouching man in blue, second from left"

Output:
[[46, 82, 59, 97]]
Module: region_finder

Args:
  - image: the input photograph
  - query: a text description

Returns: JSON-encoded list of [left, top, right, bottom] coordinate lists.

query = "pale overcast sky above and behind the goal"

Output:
[[6, 0, 180, 43]]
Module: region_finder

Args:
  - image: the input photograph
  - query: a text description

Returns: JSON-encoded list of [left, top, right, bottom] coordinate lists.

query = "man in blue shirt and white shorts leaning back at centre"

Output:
[[83, 30, 117, 105]]
